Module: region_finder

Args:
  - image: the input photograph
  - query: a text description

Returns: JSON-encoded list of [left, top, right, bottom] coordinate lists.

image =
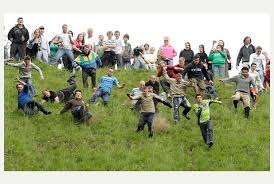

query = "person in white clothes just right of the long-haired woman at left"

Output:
[[36, 26, 50, 63]]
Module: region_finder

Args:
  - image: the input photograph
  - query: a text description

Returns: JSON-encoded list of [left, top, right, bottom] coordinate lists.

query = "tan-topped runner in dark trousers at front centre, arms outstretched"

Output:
[[127, 86, 164, 138]]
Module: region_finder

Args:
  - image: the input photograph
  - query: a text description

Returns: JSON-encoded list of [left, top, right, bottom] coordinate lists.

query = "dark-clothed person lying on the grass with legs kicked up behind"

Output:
[[42, 75, 77, 103]]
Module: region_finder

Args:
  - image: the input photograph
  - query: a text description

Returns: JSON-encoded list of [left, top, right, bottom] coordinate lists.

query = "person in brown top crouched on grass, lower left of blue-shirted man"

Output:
[[60, 90, 92, 123]]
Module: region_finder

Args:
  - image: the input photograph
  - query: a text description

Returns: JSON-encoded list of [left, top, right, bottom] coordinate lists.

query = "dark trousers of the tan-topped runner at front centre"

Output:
[[137, 112, 154, 135]]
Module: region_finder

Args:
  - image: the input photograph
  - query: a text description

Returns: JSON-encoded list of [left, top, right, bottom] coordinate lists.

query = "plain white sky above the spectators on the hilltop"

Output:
[[4, 14, 270, 74]]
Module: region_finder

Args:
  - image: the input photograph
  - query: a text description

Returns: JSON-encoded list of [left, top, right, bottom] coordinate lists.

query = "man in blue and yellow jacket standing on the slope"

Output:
[[72, 45, 102, 89]]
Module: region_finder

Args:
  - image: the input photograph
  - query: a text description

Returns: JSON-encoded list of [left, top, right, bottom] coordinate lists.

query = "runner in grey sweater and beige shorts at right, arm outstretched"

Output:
[[220, 66, 257, 120]]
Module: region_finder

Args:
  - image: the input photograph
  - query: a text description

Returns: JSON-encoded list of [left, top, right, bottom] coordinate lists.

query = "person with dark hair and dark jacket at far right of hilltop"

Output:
[[236, 36, 256, 69]]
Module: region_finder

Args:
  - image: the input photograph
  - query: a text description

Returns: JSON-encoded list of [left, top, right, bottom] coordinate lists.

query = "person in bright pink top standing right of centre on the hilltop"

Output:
[[160, 36, 177, 65]]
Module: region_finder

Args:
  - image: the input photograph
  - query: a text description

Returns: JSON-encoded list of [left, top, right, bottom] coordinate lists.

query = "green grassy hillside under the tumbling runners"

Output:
[[4, 62, 270, 171]]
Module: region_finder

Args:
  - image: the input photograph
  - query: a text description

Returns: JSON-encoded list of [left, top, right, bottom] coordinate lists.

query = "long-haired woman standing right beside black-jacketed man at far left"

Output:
[[26, 29, 41, 58]]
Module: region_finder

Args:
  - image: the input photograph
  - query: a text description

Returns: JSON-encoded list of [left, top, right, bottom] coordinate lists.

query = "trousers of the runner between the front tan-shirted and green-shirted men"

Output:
[[173, 96, 191, 121]]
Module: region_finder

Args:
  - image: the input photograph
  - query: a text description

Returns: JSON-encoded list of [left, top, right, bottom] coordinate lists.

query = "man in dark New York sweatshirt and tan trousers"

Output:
[[182, 54, 213, 95]]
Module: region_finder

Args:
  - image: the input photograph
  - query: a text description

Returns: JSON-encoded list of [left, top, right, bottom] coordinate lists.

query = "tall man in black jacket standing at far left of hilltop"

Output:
[[8, 17, 29, 60]]
